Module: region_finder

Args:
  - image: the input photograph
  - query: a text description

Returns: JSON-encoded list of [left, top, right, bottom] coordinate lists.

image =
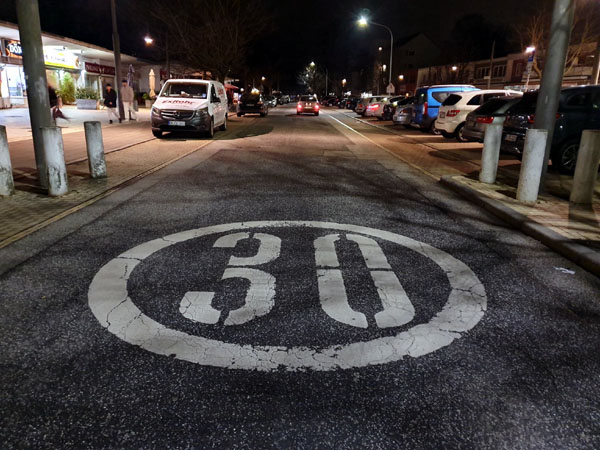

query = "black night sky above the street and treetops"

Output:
[[0, 0, 551, 89]]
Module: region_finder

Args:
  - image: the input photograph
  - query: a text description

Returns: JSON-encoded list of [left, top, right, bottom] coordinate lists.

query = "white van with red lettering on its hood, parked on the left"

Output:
[[151, 80, 227, 138]]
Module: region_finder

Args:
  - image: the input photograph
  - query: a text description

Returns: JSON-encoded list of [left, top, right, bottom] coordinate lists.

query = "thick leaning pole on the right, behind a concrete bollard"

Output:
[[533, 0, 575, 192]]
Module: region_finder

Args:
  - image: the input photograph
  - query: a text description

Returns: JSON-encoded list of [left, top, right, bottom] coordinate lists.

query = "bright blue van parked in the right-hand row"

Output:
[[411, 84, 477, 131]]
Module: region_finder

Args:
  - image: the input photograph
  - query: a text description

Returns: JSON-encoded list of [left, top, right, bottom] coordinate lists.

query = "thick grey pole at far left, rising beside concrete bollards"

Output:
[[16, 0, 53, 188]]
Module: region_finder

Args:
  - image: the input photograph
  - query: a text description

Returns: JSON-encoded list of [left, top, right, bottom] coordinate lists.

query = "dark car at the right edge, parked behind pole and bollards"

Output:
[[501, 85, 600, 173]]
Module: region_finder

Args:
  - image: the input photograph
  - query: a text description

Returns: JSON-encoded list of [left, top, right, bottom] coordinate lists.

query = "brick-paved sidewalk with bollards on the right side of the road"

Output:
[[338, 110, 600, 276]]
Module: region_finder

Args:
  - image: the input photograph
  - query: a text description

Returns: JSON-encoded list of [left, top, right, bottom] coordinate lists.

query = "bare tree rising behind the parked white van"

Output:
[[151, 0, 271, 81]]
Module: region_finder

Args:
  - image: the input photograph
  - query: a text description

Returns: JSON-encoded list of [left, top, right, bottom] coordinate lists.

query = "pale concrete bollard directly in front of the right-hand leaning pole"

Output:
[[517, 129, 548, 203]]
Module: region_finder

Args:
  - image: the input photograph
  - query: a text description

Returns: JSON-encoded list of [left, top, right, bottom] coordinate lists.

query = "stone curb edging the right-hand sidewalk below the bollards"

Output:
[[440, 175, 600, 277]]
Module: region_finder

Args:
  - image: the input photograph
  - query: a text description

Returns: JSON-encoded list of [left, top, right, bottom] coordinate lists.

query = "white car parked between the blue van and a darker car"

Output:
[[434, 89, 521, 142]]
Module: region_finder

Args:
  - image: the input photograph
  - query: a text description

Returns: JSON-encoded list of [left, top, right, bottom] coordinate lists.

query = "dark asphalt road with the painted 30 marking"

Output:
[[0, 103, 600, 450]]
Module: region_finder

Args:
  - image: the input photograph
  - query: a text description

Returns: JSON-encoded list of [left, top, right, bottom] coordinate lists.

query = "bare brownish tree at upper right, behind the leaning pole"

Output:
[[517, 0, 600, 78]]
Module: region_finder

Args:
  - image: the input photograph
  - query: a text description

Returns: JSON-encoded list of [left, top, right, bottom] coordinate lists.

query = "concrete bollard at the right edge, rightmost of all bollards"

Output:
[[570, 130, 600, 204]]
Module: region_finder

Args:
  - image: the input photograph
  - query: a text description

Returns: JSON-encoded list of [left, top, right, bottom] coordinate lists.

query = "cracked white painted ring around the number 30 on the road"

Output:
[[88, 221, 487, 371]]
